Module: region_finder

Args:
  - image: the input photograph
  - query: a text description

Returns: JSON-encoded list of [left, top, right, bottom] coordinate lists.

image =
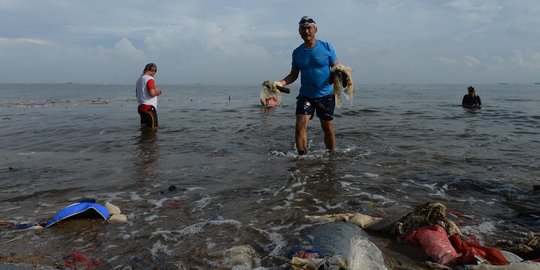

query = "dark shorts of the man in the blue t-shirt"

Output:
[[296, 95, 336, 120]]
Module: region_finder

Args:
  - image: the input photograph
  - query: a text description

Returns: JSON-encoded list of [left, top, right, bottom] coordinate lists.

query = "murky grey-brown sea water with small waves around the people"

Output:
[[0, 84, 540, 269]]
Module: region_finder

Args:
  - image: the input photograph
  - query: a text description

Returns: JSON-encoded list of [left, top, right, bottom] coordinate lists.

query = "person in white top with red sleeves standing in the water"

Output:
[[135, 63, 161, 129]]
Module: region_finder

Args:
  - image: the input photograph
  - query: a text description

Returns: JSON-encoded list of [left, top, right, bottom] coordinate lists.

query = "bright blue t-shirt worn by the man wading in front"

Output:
[[292, 40, 337, 98]]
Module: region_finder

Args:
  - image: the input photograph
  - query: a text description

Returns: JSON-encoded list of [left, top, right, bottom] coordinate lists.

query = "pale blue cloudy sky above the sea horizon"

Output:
[[0, 0, 540, 84]]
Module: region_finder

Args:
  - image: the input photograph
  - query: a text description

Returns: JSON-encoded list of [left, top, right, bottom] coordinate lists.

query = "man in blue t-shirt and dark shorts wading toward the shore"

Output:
[[276, 16, 339, 155]]
